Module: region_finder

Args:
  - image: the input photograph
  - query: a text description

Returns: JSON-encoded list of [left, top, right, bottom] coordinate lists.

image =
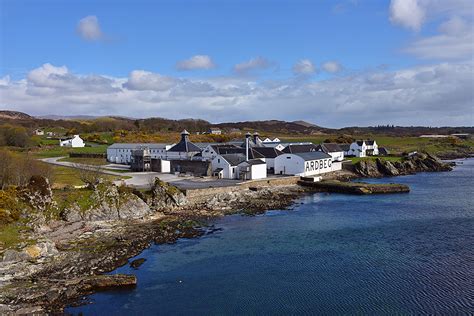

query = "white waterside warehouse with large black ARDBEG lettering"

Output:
[[275, 151, 342, 177]]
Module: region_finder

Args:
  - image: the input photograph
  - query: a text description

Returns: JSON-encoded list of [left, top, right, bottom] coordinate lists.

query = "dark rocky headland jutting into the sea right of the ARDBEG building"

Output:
[[354, 153, 452, 178]]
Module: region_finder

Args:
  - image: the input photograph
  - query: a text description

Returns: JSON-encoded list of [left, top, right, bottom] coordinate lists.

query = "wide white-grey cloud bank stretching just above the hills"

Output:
[[0, 62, 474, 127]]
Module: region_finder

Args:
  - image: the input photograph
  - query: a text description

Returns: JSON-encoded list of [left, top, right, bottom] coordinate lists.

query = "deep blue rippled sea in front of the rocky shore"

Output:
[[67, 159, 474, 315]]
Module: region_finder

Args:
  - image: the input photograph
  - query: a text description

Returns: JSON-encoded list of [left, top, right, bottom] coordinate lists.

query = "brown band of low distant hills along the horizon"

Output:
[[0, 110, 474, 137]]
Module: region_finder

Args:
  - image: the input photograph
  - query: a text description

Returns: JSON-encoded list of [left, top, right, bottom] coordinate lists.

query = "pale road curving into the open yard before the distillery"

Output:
[[41, 157, 240, 190]]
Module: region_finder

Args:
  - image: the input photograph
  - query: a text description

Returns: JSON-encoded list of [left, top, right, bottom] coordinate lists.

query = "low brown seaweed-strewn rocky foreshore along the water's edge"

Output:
[[0, 154, 460, 313]]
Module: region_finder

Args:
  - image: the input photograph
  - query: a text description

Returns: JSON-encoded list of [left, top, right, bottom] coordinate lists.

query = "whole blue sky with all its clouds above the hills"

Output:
[[0, 0, 474, 127]]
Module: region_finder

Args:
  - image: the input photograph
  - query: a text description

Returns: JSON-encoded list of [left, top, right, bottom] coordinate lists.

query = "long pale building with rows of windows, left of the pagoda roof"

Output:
[[107, 143, 171, 164]]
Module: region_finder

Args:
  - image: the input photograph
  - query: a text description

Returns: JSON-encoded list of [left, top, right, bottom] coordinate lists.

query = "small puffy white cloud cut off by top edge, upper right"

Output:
[[390, 0, 425, 31]]
